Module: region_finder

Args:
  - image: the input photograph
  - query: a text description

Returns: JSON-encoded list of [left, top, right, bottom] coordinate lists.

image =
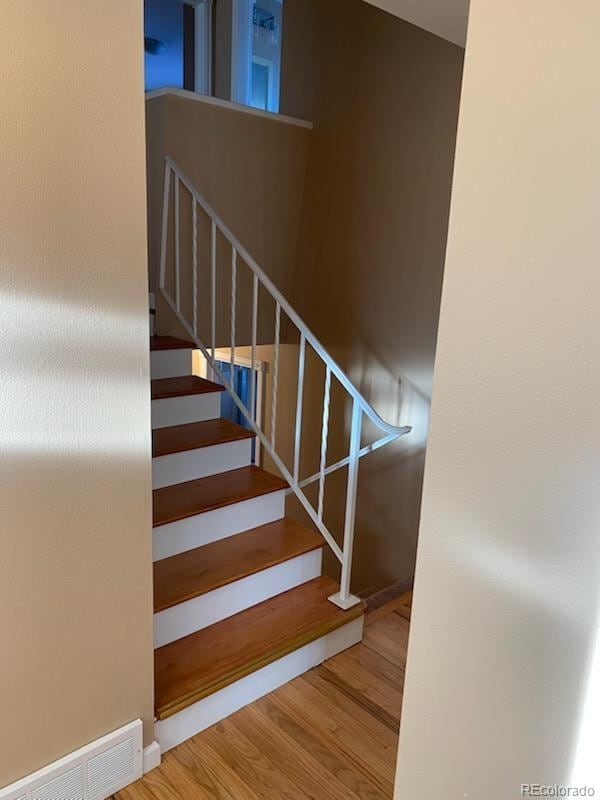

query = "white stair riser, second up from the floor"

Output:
[[154, 548, 322, 648]]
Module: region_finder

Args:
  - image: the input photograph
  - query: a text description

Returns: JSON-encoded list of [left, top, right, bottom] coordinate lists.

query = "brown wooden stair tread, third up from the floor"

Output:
[[152, 466, 287, 527]]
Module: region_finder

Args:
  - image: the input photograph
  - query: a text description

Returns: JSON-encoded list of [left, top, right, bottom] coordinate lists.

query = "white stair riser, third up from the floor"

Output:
[[152, 489, 285, 561]]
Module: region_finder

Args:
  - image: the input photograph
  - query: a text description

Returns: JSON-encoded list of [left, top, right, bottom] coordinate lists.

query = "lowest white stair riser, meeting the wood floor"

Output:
[[155, 617, 364, 753]]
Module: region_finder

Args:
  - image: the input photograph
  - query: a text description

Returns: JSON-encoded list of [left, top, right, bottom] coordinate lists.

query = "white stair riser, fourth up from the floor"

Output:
[[152, 439, 252, 489]]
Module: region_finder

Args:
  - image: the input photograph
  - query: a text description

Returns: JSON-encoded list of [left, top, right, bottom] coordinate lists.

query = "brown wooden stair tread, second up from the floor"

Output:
[[154, 517, 324, 612]]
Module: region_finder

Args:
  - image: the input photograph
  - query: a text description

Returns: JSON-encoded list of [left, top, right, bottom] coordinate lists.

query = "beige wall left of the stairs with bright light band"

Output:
[[0, 0, 152, 786]]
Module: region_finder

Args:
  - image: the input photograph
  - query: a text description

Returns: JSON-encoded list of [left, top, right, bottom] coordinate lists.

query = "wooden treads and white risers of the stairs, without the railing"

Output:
[[151, 337, 363, 752]]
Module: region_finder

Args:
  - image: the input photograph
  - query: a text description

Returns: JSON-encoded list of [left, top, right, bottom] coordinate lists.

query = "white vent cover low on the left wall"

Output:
[[0, 720, 143, 800]]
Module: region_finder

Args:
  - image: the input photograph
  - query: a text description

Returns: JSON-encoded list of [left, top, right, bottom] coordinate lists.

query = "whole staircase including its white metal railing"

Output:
[[151, 158, 411, 752]]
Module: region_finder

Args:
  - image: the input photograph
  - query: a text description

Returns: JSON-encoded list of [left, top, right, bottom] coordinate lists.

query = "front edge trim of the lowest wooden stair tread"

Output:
[[155, 603, 364, 720]]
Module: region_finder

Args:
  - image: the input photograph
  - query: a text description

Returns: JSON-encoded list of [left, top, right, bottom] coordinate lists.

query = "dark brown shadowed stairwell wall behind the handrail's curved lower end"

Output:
[[281, 0, 463, 592]]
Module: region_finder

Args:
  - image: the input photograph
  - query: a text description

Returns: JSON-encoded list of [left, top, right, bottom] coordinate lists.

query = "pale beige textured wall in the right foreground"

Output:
[[396, 0, 600, 800]]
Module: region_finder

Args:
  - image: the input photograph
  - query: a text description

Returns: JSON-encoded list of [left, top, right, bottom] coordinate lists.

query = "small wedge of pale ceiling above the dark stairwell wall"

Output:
[[366, 0, 469, 47]]
